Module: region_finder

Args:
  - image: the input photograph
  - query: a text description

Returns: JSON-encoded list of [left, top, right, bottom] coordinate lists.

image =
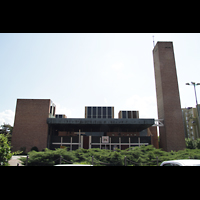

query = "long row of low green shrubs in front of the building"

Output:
[[17, 145, 200, 166]]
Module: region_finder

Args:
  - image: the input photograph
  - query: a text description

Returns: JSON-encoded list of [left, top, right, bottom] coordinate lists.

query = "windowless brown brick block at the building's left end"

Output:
[[11, 99, 51, 152]]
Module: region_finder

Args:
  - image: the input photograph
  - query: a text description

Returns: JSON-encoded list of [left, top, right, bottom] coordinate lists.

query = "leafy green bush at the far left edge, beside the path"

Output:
[[0, 134, 13, 166]]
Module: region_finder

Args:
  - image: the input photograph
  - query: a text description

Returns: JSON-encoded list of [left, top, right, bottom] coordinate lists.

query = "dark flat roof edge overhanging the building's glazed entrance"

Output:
[[47, 118, 155, 132]]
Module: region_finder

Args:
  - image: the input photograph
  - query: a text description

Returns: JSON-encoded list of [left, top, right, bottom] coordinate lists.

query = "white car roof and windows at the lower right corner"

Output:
[[160, 159, 200, 166]]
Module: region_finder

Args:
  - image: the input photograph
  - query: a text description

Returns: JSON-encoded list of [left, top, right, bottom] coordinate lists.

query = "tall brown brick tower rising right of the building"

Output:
[[153, 42, 186, 151]]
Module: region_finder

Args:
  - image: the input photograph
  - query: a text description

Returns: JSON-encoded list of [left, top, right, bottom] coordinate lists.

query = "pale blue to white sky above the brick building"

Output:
[[0, 33, 200, 125]]
